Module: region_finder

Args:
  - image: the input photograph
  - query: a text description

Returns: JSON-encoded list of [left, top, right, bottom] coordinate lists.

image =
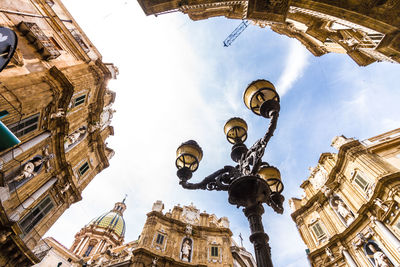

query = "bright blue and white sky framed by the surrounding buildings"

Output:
[[47, 0, 400, 267]]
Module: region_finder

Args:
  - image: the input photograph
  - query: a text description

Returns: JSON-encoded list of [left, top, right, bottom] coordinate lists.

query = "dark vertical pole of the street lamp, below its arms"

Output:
[[243, 204, 273, 267]]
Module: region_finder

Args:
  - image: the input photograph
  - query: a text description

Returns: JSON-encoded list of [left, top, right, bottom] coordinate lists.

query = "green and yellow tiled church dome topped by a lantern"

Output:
[[88, 199, 126, 237]]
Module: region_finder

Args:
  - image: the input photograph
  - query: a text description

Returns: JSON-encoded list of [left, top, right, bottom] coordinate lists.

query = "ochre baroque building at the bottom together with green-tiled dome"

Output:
[[37, 200, 256, 267]]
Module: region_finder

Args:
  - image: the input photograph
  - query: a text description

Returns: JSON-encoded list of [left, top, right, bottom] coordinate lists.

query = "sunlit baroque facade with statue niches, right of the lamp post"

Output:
[[289, 128, 400, 267]]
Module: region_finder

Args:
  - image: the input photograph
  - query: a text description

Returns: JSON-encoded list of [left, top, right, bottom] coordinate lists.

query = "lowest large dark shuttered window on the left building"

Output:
[[19, 196, 54, 234]]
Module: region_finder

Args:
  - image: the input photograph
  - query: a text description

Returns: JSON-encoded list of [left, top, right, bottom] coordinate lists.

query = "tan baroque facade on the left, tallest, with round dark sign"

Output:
[[0, 0, 118, 266]]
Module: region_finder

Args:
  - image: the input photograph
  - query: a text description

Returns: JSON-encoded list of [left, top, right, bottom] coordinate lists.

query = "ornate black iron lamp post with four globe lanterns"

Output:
[[175, 80, 284, 267]]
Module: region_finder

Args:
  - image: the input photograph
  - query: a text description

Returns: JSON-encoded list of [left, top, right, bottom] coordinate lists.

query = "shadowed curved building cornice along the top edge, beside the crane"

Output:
[[138, 0, 400, 66]]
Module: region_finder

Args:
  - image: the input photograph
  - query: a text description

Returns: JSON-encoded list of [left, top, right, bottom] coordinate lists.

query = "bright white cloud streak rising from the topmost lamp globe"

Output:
[[276, 40, 309, 96]]
